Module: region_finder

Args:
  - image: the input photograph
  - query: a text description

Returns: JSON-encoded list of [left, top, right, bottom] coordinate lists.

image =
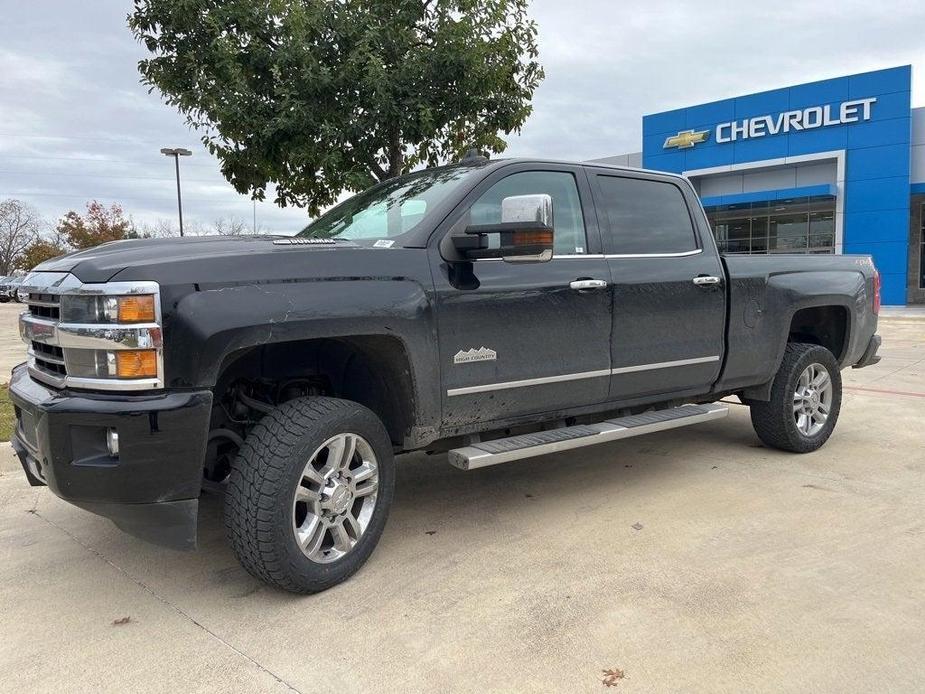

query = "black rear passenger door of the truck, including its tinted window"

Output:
[[590, 169, 726, 400]]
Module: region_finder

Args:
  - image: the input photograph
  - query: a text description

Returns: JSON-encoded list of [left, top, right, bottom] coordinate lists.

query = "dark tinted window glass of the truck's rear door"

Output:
[[597, 175, 696, 255]]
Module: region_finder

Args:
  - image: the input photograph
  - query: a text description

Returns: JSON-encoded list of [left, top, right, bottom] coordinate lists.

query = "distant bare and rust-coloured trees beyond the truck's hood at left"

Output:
[[0, 198, 262, 277]]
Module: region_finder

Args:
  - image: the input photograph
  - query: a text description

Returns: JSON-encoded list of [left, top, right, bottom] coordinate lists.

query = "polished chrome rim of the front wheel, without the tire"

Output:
[[292, 434, 379, 564]]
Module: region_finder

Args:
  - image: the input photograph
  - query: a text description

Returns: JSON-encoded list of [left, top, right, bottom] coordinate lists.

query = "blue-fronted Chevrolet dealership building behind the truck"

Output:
[[596, 65, 925, 305]]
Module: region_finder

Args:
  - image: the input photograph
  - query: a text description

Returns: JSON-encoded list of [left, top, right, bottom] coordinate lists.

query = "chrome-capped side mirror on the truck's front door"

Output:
[[454, 193, 554, 263]]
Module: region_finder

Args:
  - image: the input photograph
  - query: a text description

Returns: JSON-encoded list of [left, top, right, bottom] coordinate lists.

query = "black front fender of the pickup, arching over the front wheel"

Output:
[[165, 277, 440, 438]]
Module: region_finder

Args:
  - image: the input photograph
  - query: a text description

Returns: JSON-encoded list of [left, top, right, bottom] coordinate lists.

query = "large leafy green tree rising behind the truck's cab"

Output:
[[128, 0, 543, 215]]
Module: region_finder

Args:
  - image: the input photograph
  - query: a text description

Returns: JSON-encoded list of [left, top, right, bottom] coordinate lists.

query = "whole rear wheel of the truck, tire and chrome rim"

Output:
[[750, 342, 842, 453]]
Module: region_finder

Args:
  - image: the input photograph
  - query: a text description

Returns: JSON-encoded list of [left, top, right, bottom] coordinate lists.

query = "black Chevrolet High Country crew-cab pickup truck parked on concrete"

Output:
[[10, 160, 880, 592]]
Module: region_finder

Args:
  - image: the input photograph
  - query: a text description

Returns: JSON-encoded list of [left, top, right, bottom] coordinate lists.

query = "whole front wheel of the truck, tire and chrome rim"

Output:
[[225, 397, 395, 593]]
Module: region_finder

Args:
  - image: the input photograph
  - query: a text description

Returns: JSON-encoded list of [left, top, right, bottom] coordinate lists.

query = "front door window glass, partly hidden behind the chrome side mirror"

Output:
[[464, 171, 587, 255]]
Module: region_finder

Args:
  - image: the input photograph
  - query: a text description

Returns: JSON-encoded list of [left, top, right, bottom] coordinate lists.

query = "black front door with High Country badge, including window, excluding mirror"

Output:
[[431, 165, 611, 429]]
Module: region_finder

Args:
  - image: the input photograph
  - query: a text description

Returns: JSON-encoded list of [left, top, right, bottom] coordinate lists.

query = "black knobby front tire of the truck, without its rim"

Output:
[[225, 397, 395, 593]]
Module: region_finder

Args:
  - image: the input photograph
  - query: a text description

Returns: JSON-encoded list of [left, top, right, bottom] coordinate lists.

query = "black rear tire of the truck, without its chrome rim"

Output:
[[749, 342, 842, 453]]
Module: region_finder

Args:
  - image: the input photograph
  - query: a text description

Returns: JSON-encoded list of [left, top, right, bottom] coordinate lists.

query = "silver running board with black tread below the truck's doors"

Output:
[[449, 404, 729, 470]]
